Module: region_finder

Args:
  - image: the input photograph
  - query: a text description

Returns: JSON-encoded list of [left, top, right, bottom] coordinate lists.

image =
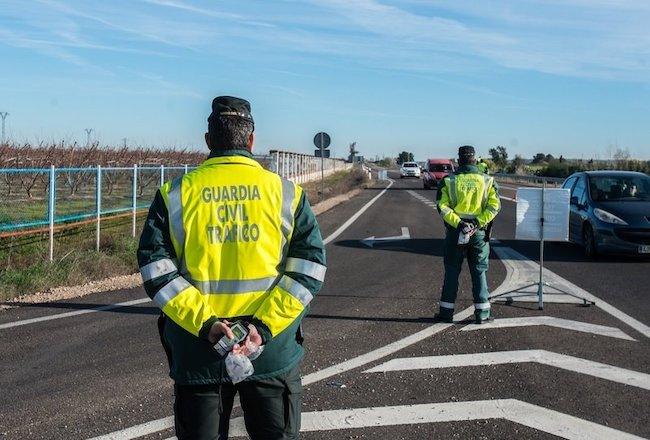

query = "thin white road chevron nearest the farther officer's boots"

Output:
[[461, 316, 636, 341]]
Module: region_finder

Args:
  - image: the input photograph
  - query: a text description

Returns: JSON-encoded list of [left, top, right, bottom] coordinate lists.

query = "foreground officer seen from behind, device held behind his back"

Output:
[[138, 96, 326, 440]]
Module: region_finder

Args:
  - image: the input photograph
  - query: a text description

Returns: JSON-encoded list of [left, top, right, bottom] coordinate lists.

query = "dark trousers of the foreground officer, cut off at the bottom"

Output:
[[174, 367, 302, 440]]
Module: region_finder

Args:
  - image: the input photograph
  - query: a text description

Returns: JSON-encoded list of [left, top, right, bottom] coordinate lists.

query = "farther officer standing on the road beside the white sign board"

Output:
[[434, 145, 501, 324]]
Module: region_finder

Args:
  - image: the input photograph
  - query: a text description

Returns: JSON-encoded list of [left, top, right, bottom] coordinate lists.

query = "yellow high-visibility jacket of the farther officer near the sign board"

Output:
[[438, 172, 501, 228]]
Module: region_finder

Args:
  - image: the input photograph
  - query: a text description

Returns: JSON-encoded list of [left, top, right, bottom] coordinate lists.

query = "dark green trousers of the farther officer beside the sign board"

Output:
[[440, 227, 490, 319]]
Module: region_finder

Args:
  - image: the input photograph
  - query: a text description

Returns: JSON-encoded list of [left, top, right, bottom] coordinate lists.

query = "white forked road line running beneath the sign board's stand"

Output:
[[492, 246, 650, 338]]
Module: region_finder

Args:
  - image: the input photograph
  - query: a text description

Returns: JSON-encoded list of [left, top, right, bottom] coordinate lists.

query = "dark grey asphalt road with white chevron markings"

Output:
[[0, 174, 650, 439]]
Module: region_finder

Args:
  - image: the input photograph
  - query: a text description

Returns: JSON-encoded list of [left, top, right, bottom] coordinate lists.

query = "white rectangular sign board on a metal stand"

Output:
[[515, 188, 569, 241]]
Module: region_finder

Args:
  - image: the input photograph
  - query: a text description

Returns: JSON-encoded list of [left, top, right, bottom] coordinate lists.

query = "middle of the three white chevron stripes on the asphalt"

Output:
[[364, 350, 650, 390]]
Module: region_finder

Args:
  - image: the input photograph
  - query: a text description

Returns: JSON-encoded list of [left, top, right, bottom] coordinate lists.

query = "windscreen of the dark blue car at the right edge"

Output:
[[589, 174, 650, 202]]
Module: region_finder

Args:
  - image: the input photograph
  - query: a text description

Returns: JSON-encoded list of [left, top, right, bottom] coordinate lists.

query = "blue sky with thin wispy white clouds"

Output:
[[0, 0, 650, 159]]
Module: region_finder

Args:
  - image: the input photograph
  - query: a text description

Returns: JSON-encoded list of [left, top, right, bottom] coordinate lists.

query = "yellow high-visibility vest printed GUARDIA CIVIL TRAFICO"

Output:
[[154, 156, 314, 336]]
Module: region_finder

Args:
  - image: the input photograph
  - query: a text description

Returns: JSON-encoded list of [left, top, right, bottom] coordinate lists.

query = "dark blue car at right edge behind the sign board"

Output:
[[562, 171, 650, 258]]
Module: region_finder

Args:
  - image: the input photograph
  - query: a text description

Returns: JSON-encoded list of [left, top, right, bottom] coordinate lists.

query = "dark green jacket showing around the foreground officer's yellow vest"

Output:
[[138, 150, 326, 385]]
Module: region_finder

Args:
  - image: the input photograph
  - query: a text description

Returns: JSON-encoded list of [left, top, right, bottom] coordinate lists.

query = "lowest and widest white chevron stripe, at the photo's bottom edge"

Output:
[[219, 399, 642, 440]]
